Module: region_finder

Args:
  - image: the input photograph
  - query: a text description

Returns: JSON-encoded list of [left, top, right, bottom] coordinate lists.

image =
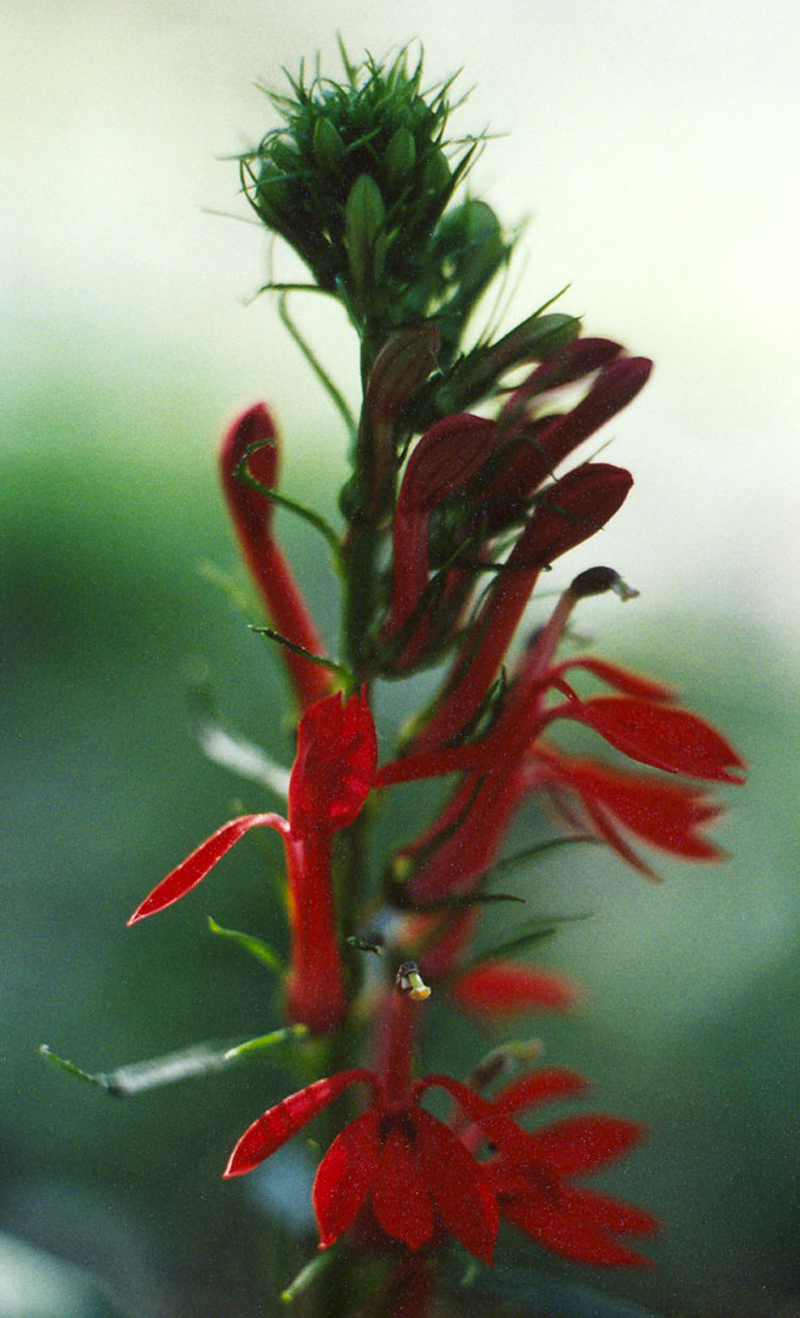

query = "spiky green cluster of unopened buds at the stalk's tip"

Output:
[[241, 50, 511, 358]]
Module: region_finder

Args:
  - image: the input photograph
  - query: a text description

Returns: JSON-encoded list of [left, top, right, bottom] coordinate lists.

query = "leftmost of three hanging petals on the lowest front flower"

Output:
[[312, 1110, 380, 1248]]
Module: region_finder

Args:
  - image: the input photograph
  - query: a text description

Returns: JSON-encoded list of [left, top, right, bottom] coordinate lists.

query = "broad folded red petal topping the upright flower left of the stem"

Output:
[[289, 691, 378, 833]]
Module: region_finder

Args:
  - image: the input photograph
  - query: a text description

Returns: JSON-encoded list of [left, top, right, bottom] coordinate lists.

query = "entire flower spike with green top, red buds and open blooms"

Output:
[[71, 43, 743, 1314]]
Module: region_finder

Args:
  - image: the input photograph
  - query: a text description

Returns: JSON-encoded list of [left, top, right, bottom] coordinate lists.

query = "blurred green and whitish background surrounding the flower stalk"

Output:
[[0, 0, 800, 1318]]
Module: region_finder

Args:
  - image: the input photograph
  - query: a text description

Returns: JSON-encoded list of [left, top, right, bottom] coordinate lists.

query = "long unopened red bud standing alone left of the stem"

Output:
[[220, 403, 331, 709]]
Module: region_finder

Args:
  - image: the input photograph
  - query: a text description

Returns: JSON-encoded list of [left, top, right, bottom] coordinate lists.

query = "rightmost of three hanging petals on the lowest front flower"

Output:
[[414, 1108, 498, 1264]]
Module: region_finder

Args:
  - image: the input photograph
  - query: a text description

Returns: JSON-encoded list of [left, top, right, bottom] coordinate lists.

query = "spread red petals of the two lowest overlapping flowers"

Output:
[[224, 1038, 658, 1264]]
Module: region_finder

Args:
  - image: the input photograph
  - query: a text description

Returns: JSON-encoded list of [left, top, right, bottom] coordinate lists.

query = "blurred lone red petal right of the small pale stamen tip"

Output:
[[451, 961, 579, 1016]]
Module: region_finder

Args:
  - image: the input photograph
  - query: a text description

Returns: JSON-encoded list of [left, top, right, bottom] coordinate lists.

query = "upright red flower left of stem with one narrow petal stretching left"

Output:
[[128, 692, 377, 1033]]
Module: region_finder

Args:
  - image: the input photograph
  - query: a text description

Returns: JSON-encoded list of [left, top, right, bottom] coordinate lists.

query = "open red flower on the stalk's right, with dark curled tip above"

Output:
[[380, 568, 743, 980]]
